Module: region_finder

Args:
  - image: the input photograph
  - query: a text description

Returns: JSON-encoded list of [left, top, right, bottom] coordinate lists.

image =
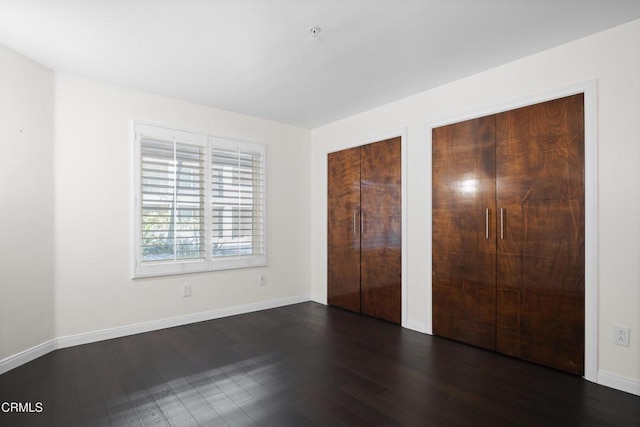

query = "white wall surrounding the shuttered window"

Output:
[[55, 75, 310, 337]]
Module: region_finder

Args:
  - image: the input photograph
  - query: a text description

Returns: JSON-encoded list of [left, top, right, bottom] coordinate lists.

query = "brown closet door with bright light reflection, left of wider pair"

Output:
[[432, 116, 496, 350]]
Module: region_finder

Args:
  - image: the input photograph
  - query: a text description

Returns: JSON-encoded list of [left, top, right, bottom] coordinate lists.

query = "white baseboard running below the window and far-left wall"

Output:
[[0, 295, 311, 375]]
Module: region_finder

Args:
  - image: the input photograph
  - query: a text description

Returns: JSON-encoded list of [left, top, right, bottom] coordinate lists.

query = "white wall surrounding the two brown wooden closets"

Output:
[[311, 20, 640, 393]]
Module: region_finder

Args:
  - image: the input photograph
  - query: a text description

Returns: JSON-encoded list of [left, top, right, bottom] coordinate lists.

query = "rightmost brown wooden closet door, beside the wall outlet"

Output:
[[496, 94, 584, 375]]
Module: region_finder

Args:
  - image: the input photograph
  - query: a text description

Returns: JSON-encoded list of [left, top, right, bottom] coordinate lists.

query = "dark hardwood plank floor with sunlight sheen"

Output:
[[0, 303, 640, 426]]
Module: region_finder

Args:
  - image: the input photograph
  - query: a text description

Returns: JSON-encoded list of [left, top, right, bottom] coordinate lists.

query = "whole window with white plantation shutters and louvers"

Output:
[[134, 123, 266, 277]]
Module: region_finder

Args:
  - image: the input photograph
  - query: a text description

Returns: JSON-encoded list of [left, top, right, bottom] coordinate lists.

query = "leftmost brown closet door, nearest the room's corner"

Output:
[[327, 147, 361, 313]]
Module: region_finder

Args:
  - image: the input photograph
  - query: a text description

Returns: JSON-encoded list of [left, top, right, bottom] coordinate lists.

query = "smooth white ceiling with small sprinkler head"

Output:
[[0, 0, 640, 128]]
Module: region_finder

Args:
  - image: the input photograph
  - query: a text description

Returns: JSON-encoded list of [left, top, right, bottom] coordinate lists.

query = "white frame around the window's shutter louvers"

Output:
[[131, 121, 267, 279]]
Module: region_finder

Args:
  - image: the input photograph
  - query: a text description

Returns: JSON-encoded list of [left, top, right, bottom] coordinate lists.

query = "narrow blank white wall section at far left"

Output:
[[0, 45, 54, 360]]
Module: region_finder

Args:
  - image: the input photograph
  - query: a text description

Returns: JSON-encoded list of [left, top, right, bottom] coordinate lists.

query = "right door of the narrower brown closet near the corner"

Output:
[[361, 137, 402, 323]]
